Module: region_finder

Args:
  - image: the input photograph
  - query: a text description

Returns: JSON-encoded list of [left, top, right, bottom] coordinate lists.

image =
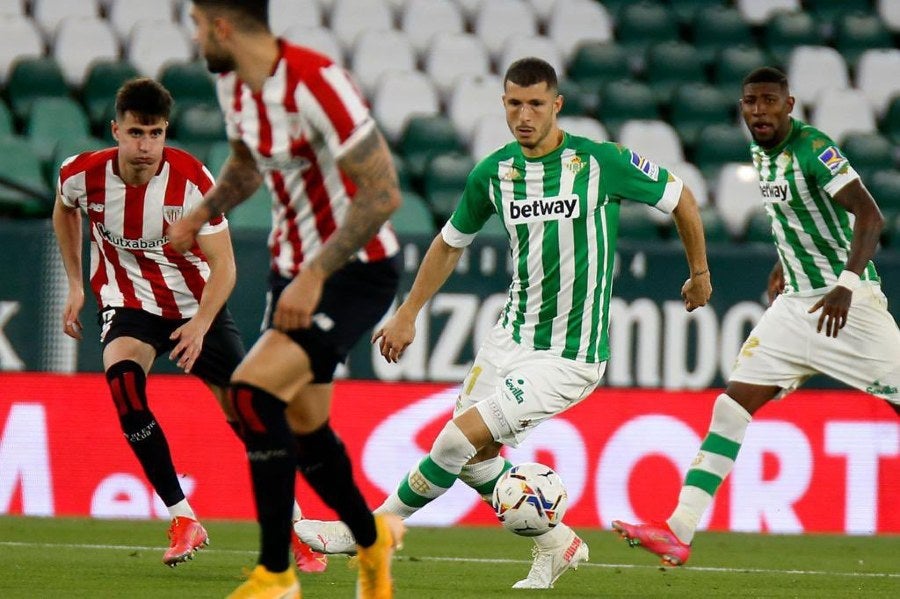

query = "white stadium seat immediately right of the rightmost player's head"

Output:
[[786, 46, 850, 109]]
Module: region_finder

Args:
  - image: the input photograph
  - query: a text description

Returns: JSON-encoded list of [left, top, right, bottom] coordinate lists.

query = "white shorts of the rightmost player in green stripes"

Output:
[[729, 284, 900, 404]]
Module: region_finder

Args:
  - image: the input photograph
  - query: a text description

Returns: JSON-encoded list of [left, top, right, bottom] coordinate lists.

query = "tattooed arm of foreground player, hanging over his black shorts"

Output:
[[272, 128, 401, 331]]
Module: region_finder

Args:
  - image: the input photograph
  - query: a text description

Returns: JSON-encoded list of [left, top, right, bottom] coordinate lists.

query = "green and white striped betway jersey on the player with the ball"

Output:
[[442, 134, 682, 363]]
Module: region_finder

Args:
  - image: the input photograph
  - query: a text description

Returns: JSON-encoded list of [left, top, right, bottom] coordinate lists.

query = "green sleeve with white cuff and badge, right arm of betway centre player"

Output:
[[600, 144, 684, 214]]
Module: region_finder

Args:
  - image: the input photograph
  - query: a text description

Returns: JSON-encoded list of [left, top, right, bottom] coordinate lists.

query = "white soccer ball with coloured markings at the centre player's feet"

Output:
[[492, 462, 569, 537]]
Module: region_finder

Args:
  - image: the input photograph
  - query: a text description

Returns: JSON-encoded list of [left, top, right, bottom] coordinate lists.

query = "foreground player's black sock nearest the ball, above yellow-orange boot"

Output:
[[294, 422, 375, 547]]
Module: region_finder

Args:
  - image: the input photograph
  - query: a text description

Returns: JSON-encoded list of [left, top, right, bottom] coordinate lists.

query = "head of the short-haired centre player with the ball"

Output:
[[503, 57, 563, 156]]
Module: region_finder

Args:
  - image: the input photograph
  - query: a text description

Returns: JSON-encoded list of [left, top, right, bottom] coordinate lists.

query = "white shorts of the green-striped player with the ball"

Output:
[[454, 325, 606, 447]]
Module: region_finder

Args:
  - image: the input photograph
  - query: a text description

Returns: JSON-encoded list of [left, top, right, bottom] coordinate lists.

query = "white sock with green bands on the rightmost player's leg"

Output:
[[666, 393, 752, 544]]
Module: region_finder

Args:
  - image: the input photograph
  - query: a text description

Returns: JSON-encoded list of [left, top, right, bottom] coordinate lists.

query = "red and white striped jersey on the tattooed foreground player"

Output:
[[217, 40, 399, 278]]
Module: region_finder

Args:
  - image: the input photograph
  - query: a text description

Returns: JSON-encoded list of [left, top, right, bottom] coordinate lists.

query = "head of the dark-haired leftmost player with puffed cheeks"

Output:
[[112, 77, 172, 175]]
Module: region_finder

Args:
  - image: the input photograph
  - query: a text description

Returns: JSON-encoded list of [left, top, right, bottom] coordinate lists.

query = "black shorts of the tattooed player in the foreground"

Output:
[[263, 256, 400, 383]]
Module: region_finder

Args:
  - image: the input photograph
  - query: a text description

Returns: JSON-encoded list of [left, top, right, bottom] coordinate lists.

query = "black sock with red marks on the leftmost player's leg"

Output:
[[106, 360, 184, 506]]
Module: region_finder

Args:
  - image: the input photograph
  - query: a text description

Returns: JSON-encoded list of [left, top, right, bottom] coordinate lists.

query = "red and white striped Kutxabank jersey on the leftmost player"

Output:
[[57, 147, 228, 318]]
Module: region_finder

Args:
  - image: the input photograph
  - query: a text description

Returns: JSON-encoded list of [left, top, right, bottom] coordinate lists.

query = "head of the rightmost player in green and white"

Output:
[[741, 67, 794, 148]]
